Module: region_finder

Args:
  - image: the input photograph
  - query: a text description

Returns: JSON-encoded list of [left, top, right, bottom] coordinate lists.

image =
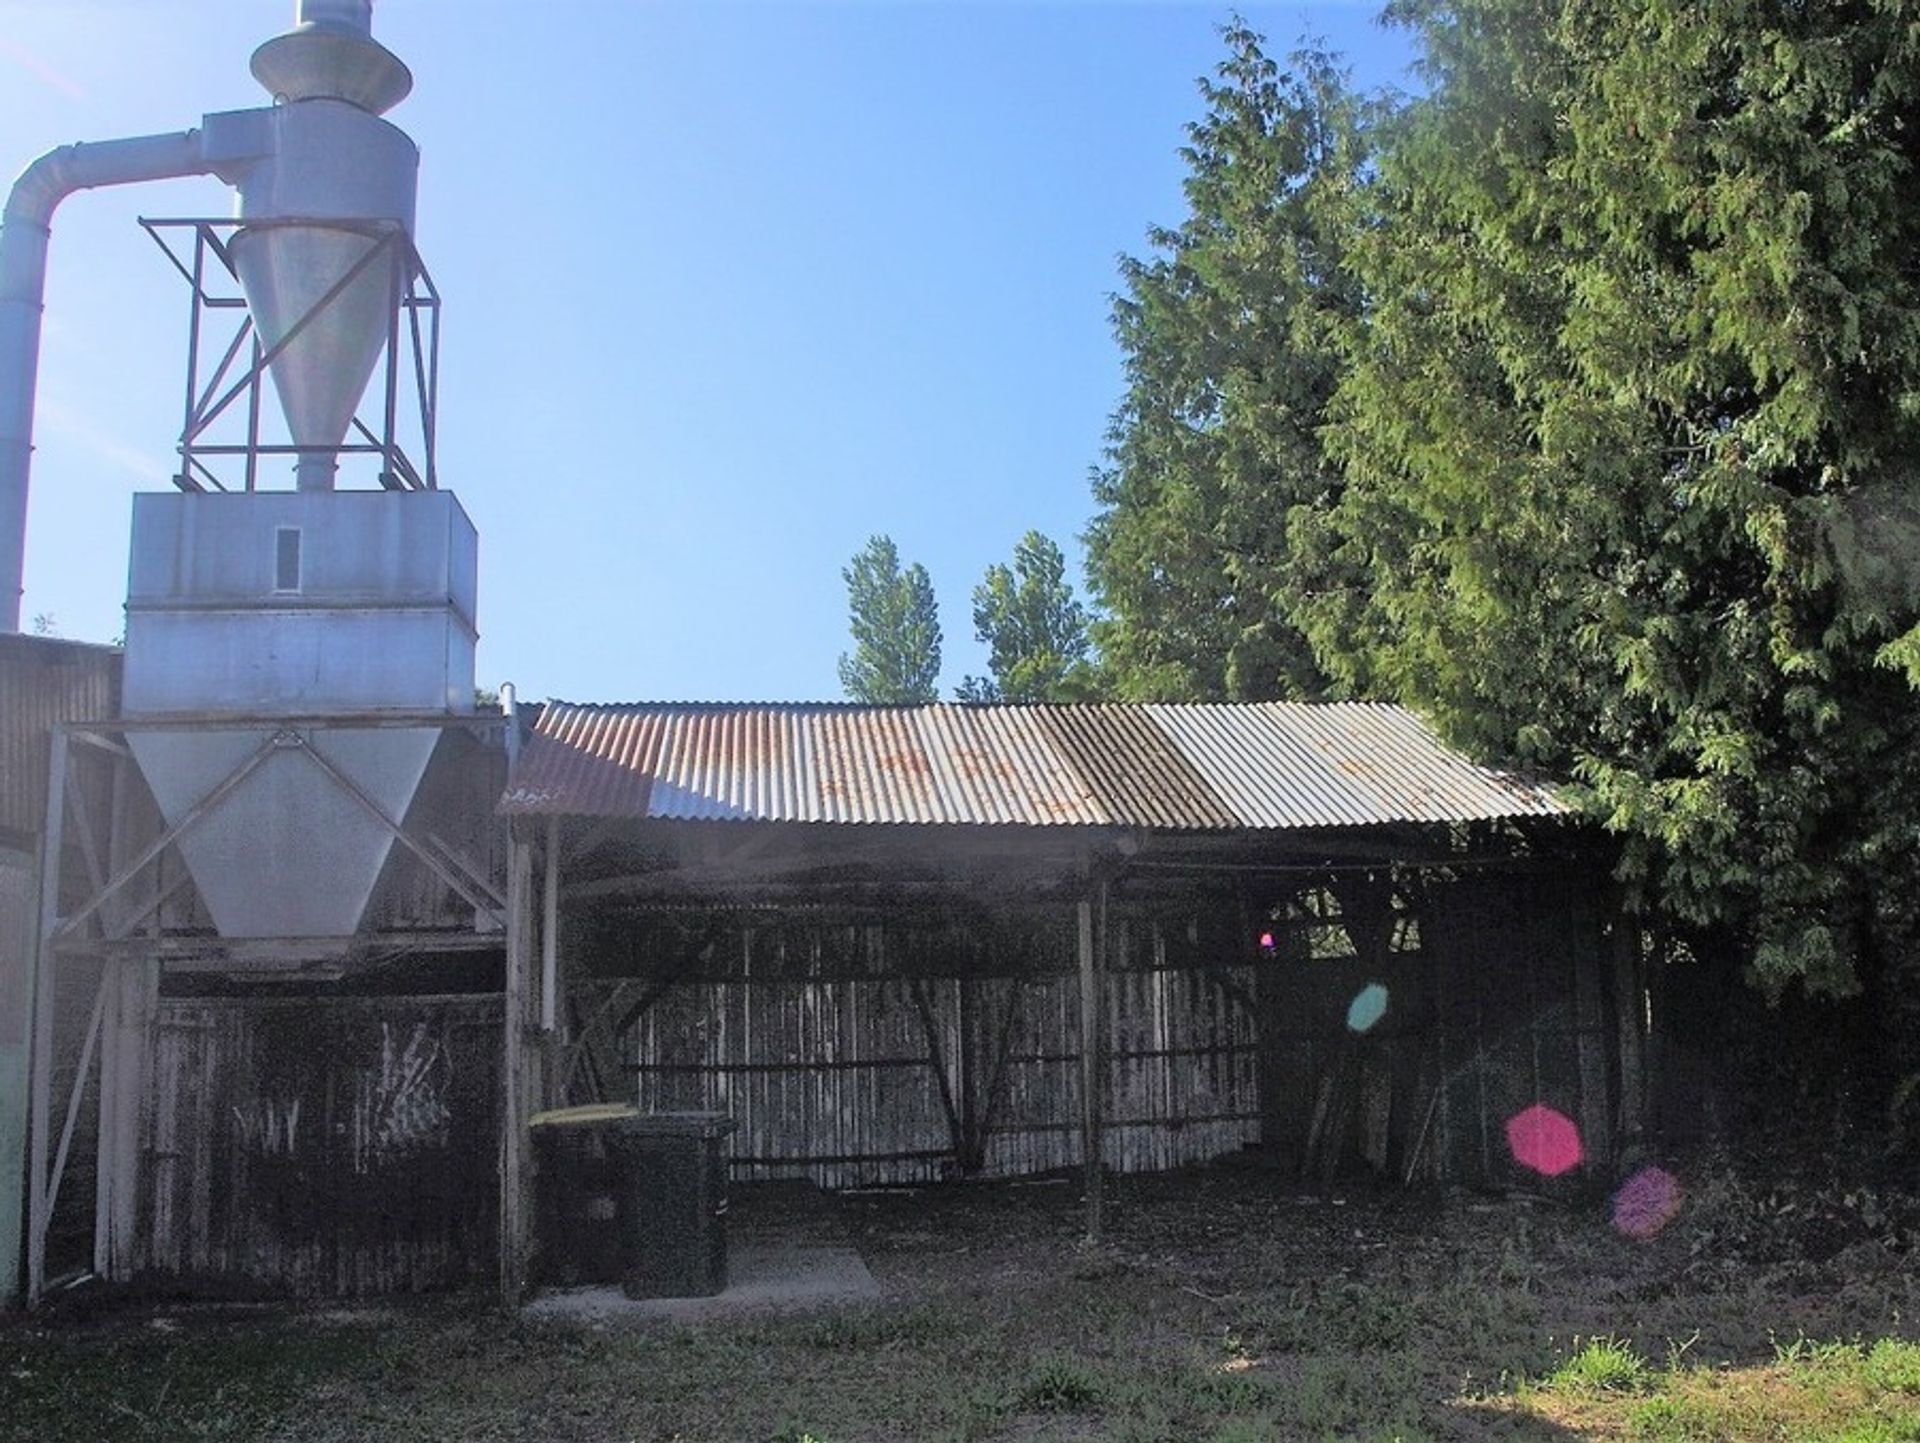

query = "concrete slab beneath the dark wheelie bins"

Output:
[[522, 1243, 879, 1322]]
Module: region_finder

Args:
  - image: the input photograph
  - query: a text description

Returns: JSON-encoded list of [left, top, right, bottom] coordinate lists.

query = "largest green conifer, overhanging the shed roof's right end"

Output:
[[1292, 0, 1920, 994]]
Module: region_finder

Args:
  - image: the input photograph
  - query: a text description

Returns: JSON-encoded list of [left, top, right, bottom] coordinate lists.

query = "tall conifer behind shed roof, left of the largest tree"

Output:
[[1087, 21, 1375, 700]]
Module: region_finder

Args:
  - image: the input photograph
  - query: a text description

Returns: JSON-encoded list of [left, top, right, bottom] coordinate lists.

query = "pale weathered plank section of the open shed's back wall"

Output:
[[603, 925, 1260, 1188]]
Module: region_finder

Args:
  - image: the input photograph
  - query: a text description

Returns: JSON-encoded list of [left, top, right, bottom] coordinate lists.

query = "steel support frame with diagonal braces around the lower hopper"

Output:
[[25, 712, 506, 1307]]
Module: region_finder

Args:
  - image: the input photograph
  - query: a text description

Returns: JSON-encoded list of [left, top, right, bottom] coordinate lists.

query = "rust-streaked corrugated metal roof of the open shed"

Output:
[[501, 702, 1569, 831]]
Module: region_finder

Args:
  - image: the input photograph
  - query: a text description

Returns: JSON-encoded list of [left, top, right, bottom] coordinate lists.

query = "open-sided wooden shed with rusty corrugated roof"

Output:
[[487, 702, 1644, 1282]]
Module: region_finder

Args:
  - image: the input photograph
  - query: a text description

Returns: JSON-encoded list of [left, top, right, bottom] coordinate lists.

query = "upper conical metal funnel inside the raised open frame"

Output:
[[230, 225, 405, 491]]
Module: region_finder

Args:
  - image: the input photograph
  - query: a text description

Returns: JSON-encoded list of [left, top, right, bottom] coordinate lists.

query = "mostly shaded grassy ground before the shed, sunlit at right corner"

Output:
[[0, 1174, 1920, 1443]]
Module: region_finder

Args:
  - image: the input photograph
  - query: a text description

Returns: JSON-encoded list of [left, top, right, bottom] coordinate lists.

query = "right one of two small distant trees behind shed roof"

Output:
[[958, 532, 1094, 702]]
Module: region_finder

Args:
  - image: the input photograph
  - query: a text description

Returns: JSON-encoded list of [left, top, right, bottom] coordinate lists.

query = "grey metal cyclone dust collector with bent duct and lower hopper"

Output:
[[0, 0, 476, 954]]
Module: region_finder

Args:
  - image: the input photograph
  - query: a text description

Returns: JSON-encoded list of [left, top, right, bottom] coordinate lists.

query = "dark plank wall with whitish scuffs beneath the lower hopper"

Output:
[[138, 996, 501, 1297]]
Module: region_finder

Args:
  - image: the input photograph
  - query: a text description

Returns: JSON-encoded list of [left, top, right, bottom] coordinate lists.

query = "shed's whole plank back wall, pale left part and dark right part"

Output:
[[576, 867, 1620, 1188]]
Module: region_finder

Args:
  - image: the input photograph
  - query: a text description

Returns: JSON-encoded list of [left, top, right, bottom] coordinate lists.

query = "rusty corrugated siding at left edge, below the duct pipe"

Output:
[[0, 633, 121, 840]]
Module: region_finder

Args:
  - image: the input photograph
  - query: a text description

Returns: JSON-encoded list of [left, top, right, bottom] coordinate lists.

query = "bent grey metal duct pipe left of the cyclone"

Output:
[[0, 130, 211, 633]]
